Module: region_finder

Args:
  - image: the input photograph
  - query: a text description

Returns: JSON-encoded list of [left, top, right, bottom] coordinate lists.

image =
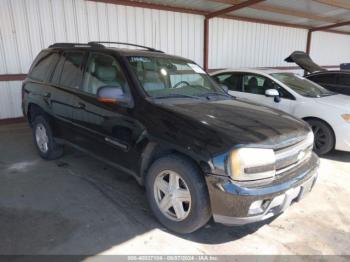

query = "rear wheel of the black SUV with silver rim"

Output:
[[32, 115, 63, 160]]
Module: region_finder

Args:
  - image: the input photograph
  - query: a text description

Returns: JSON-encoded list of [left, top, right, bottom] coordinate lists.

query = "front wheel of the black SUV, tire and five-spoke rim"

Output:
[[146, 154, 211, 234]]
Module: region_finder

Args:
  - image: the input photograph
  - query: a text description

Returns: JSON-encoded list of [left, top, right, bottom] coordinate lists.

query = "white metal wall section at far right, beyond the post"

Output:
[[310, 32, 350, 65]]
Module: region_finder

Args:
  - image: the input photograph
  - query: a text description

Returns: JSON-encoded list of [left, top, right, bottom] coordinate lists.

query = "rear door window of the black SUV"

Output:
[[60, 52, 84, 88]]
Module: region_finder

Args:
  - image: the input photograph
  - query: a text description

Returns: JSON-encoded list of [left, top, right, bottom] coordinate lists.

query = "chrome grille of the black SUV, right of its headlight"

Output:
[[275, 139, 312, 175]]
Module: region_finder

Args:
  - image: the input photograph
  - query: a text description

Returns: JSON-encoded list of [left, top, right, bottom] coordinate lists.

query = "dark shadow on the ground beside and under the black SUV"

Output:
[[0, 125, 270, 255]]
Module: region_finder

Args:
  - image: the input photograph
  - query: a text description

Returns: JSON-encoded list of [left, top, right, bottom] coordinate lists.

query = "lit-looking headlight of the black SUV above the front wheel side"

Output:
[[230, 148, 276, 181]]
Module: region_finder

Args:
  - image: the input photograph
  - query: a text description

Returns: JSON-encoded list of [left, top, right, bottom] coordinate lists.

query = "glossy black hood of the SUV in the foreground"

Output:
[[160, 100, 310, 153]]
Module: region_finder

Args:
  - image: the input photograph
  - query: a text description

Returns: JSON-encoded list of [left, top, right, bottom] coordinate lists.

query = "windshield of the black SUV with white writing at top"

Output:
[[128, 56, 230, 99]]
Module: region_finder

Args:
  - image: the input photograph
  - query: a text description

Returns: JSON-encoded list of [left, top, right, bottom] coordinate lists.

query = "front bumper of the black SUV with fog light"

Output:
[[206, 154, 319, 225]]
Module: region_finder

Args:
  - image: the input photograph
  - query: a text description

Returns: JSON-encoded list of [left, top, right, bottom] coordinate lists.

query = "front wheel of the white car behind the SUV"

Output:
[[307, 119, 335, 155]]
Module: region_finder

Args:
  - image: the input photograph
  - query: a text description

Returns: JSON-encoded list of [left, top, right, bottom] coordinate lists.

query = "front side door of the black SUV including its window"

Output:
[[69, 52, 143, 172]]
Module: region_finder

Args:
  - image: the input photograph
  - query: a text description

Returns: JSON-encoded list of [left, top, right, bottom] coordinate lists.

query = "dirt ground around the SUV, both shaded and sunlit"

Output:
[[0, 123, 350, 256]]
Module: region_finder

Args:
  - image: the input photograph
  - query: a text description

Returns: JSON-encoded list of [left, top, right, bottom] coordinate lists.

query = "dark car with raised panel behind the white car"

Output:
[[285, 51, 350, 95]]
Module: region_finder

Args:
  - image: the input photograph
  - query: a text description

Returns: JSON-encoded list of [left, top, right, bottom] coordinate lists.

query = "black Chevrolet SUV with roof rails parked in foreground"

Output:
[[22, 42, 318, 233]]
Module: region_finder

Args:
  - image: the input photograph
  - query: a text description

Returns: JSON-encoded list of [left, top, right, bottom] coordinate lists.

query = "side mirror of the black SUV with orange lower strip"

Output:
[[97, 85, 129, 104]]
